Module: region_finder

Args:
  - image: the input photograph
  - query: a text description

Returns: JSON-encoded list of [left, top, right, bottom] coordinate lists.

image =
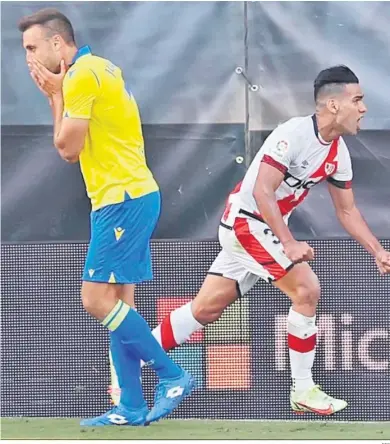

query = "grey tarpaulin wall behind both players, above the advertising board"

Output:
[[1, 2, 390, 241]]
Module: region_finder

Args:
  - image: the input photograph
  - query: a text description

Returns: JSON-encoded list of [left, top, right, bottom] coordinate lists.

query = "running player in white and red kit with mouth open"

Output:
[[109, 66, 390, 415]]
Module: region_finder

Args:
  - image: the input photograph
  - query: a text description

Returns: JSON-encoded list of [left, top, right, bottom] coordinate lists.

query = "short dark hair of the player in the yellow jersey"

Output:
[[18, 8, 76, 43]]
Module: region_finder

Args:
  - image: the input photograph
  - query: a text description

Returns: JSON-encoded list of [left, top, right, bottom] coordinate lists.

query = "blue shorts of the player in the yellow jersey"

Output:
[[83, 191, 161, 284]]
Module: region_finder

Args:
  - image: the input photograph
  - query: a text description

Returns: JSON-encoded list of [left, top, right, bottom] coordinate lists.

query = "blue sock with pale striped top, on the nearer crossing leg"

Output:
[[102, 301, 182, 379]]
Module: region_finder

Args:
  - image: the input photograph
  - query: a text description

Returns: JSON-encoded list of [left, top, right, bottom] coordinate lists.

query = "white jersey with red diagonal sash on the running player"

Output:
[[222, 116, 352, 225]]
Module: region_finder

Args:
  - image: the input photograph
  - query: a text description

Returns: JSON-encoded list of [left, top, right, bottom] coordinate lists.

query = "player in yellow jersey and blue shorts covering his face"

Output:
[[19, 9, 195, 426]]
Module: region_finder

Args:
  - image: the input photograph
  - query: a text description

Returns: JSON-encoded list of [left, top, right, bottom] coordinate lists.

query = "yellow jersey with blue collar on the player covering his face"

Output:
[[62, 46, 159, 211]]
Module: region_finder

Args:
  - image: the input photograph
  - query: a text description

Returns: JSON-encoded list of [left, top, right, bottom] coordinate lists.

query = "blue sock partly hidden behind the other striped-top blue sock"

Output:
[[110, 333, 146, 410]]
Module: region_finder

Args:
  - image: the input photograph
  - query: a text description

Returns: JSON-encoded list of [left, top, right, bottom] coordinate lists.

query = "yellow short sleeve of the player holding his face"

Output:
[[63, 66, 100, 119]]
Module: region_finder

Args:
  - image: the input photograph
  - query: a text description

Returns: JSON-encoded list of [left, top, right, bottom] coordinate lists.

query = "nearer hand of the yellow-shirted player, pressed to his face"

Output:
[[28, 57, 67, 97]]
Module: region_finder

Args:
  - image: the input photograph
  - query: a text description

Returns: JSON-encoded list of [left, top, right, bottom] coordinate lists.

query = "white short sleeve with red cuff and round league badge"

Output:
[[261, 128, 295, 174]]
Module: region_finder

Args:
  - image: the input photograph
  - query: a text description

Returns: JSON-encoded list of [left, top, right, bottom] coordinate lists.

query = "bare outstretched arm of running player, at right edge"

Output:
[[328, 183, 390, 274]]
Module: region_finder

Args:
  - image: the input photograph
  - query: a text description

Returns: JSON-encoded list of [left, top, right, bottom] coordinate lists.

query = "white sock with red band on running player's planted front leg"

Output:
[[288, 307, 318, 392]]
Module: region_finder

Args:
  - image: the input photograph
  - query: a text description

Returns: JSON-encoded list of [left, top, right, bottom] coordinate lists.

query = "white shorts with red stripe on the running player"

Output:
[[209, 217, 294, 294]]
